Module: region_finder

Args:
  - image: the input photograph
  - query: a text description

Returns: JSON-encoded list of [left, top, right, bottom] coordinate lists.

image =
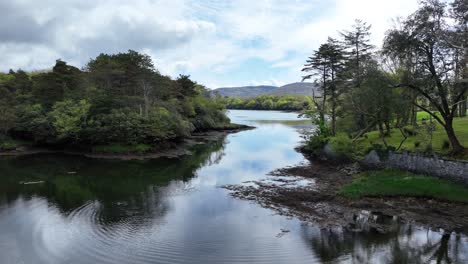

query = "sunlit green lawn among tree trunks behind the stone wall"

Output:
[[356, 112, 468, 155]]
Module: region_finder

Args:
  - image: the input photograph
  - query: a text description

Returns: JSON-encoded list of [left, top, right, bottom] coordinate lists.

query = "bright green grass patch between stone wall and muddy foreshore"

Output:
[[338, 170, 468, 203]]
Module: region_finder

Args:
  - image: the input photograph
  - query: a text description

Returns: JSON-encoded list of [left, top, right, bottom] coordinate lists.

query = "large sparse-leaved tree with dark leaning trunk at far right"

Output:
[[384, 0, 467, 154]]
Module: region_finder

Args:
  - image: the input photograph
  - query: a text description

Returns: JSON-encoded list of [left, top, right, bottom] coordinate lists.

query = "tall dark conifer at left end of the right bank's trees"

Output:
[[302, 38, 344, 135]]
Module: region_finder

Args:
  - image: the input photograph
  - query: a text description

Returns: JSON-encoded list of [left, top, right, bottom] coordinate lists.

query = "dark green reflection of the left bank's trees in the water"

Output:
[[0, 135, 225, 216]]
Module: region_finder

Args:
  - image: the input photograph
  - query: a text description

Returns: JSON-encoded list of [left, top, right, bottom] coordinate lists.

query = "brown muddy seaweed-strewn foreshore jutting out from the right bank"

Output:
[[225, 161, 468, 233]]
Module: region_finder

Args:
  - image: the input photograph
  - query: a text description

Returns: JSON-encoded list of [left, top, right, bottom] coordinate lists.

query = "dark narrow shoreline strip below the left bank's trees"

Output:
[[0, 124, 255, 160]]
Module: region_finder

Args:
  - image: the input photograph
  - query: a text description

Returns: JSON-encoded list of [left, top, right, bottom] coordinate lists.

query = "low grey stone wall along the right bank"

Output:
[[364, 151, 468, 183]]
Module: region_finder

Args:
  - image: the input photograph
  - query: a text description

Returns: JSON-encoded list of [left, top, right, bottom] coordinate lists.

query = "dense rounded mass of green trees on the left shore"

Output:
[[0, 50, 229, 148]]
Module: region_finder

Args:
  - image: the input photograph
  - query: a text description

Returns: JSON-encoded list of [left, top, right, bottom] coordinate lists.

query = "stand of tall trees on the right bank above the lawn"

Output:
[[303, 0, 468, 154]]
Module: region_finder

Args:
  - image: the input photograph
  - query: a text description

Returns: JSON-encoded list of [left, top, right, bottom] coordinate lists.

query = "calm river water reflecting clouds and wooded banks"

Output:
[[0, 111, 468, 264]]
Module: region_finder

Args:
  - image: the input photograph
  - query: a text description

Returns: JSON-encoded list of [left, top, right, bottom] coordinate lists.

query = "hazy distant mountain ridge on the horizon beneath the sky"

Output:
[[213, 82, 320, 98]]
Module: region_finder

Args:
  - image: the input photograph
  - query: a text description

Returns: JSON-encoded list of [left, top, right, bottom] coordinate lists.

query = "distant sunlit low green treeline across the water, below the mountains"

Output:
[[216, 95, 313, 111]]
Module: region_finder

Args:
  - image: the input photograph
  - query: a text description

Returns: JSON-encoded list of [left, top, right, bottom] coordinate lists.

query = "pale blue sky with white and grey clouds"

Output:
[[0, 0, 417, 88]]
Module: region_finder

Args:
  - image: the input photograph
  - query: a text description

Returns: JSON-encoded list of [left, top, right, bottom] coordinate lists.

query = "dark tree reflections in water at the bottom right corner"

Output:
[[302, 214, 467, 263]]
